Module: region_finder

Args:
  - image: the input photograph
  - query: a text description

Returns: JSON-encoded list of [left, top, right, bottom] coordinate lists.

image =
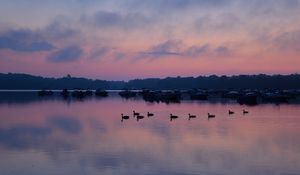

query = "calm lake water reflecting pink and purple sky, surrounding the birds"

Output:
[[0, 94, 300, 175]]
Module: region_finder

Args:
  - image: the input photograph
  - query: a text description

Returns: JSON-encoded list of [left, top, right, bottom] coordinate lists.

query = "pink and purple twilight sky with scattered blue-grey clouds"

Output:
[[0, 0, 300, 80]]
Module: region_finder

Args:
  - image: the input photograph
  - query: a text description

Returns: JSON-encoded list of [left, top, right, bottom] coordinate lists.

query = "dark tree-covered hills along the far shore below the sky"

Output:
[[0, 73, 300, 90]]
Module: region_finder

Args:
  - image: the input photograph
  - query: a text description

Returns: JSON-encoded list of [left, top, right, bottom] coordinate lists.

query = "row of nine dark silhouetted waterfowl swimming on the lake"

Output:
[[121, 110, 249, 122]]
